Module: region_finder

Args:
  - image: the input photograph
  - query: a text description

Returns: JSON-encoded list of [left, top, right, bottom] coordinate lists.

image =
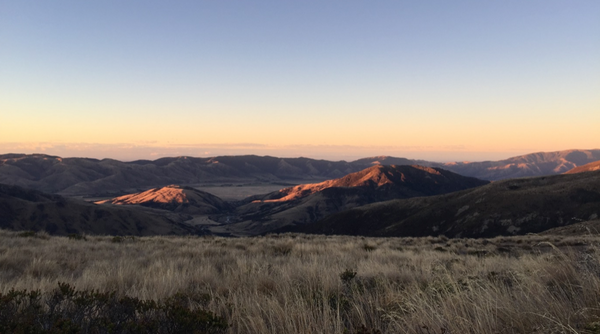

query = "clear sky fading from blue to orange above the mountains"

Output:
[[0, 0, 600, 161]]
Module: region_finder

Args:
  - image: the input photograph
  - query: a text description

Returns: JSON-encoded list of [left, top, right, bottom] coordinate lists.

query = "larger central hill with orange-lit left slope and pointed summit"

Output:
[[211, 166, 489, 235]]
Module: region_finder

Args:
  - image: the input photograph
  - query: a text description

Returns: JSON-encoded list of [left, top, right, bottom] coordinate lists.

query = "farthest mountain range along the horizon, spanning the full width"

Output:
[[0, 149, 600, 196]]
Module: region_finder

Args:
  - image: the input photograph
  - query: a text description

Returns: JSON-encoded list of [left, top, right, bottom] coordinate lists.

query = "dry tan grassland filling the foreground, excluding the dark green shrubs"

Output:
[[0, 231, 600, 334]]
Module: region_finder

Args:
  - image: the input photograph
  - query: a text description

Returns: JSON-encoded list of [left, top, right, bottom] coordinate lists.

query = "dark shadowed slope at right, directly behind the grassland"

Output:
[[291, 171, 600, 237]]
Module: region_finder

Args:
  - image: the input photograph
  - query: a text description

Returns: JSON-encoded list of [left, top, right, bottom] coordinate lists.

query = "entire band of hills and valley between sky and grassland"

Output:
[[0, 150, 600, 237]]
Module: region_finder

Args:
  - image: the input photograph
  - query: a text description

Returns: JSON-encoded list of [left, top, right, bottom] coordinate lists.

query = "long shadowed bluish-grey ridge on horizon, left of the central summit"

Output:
[[0, 154, 356, 196]]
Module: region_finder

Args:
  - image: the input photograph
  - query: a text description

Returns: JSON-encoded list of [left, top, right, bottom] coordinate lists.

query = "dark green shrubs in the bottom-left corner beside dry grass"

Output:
[[0, 283, 227, 334]]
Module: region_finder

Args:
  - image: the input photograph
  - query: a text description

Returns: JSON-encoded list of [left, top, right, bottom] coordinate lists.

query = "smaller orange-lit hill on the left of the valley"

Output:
[[95, 185, 232, 215]]
